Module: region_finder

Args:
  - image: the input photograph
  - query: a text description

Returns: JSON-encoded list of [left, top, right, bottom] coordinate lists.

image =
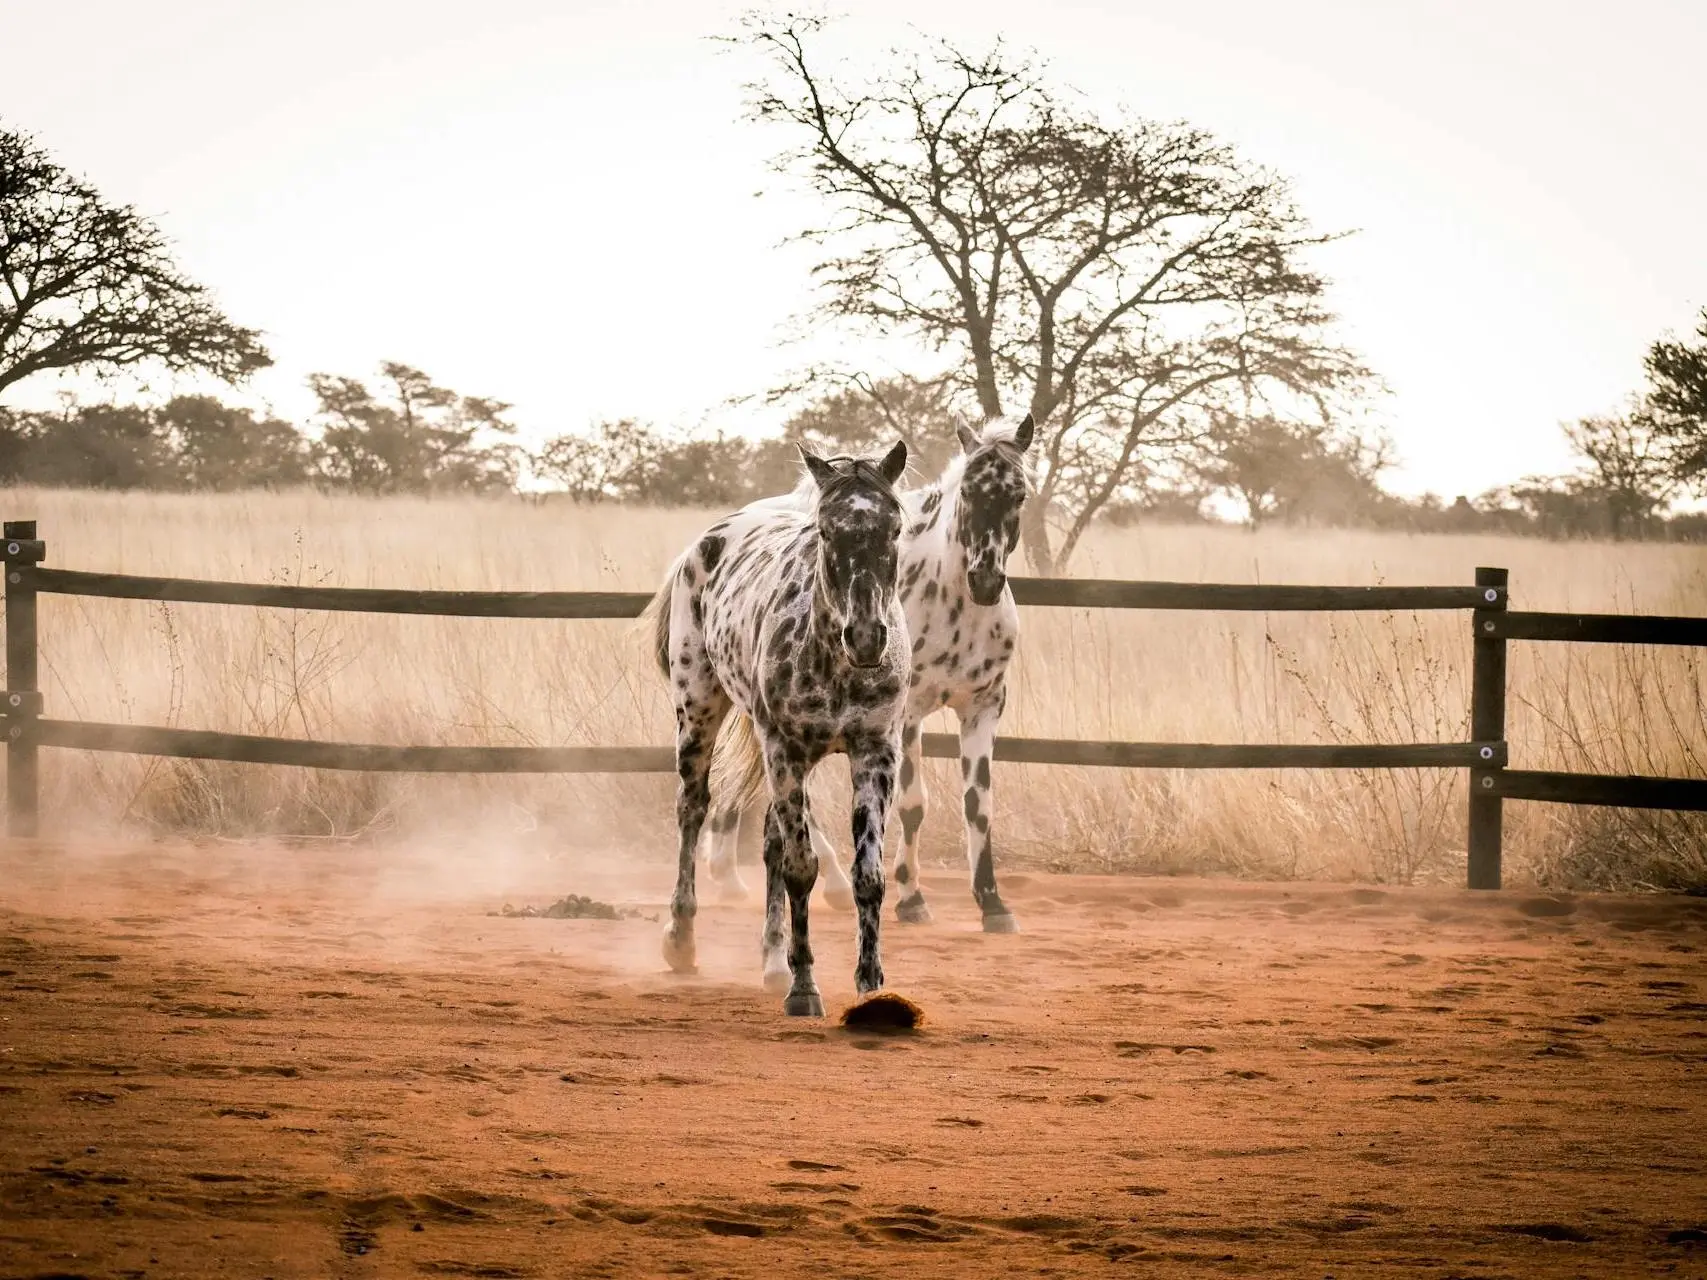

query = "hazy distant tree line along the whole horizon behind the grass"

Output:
[[10, 351, 1707, 539]]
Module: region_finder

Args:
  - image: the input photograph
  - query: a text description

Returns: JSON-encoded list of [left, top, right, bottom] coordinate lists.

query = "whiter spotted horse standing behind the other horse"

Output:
[[707, 413, 1036, 934]]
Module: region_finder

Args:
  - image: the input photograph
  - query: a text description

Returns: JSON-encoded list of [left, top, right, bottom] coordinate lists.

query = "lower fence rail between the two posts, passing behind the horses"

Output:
[[16, 720, 1506, 773]]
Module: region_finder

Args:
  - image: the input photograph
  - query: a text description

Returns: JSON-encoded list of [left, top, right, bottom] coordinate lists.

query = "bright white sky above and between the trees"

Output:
[[0, 0, 1707, 497]]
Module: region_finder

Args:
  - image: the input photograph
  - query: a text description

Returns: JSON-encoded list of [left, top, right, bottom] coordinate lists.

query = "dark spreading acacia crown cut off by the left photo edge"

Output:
[[0, 130, 271, 401]]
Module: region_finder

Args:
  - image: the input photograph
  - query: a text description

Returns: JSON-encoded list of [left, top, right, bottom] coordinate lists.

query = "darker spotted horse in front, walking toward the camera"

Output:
[[647, 444, 908, 1017]]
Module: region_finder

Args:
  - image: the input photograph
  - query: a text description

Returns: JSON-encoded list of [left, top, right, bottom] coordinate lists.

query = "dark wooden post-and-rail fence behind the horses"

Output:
[[0, 521, 1707, 889]]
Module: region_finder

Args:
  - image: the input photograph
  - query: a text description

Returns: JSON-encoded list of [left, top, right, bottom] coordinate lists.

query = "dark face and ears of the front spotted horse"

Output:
[[801, 444, 906, 667]]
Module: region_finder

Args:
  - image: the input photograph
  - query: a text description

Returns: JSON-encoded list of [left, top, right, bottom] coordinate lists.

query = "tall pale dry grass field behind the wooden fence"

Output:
[[0, 490, 1707, 887]]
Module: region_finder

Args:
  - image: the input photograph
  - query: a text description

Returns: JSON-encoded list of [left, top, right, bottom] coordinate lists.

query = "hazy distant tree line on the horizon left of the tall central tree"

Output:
[[0, 362, 963, 507]]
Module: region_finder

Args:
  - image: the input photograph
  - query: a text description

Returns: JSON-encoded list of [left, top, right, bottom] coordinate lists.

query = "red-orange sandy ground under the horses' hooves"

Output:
[[0, 847, 1707, 1278]]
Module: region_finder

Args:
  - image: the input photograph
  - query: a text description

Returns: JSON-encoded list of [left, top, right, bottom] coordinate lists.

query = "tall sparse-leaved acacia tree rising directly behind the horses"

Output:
[[736, 14, 1366, 573]]
